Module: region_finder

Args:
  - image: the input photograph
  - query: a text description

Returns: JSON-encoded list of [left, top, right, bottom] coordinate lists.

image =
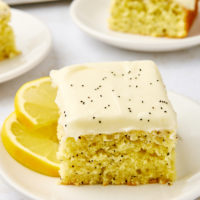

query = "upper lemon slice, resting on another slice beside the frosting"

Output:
[[15, 77, 58, 127]]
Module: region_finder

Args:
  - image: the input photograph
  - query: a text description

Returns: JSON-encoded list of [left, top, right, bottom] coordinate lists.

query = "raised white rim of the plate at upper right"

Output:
[[70, 0, 200, 52]]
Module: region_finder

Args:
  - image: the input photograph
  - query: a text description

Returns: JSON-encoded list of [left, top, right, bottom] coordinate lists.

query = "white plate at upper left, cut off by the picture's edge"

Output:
[[0, 9, 51, 83]]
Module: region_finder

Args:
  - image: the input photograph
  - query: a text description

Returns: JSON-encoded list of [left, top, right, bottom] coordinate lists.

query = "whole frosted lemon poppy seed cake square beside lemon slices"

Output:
[[50, 61, 176, 185]]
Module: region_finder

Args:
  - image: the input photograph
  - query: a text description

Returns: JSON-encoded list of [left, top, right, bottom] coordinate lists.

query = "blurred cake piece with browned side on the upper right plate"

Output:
[[109, 0, 198, 38]]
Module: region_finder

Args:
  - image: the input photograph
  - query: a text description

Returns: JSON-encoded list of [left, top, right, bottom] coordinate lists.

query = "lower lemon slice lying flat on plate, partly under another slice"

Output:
[[1, 112, 59, 176]]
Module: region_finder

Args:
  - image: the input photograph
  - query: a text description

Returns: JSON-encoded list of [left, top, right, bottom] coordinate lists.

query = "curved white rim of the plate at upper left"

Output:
[[0, 8, 52, 84]]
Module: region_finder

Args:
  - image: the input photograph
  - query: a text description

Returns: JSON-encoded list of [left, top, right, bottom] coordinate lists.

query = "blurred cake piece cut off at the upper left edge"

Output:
[[0, 0, 20, 60]]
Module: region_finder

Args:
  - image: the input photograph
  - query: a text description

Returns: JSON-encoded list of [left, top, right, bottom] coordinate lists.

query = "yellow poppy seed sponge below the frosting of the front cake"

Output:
[[59, 131, 176, 185]]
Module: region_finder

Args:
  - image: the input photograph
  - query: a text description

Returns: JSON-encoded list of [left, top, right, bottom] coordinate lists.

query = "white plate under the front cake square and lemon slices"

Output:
[[0, 93, 200, 200]]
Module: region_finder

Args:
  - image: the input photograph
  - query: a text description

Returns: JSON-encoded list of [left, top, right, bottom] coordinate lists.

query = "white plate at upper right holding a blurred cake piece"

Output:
[[71, 0, 200, 52]]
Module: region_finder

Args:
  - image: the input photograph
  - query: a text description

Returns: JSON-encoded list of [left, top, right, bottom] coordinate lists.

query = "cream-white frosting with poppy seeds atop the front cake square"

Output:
[[50, 61, 177, 138]]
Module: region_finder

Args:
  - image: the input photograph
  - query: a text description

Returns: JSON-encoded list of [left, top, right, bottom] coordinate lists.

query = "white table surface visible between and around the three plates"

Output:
[[0, 1, 200, 200]]
